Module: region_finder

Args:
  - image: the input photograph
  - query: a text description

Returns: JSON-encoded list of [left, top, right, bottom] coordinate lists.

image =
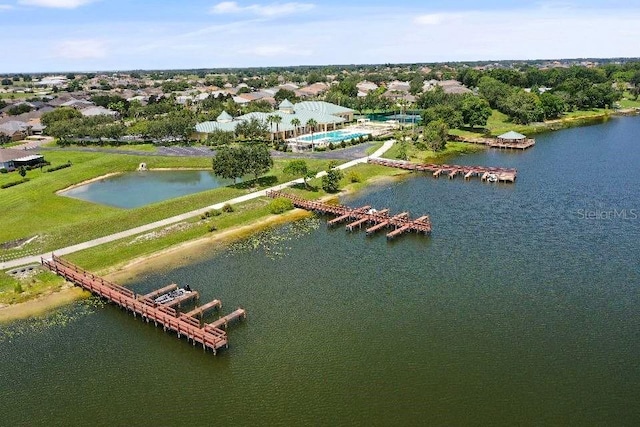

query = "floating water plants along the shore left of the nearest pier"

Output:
[[0, 297, 106, 344]]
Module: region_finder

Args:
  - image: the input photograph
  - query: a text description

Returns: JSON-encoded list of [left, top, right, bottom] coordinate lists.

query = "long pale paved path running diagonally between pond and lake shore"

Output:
[[0, 140, 394, 270]]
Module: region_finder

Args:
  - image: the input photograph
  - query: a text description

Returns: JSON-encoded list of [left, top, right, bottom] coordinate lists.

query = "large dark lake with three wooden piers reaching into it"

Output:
[[0, 117, 640, 426]]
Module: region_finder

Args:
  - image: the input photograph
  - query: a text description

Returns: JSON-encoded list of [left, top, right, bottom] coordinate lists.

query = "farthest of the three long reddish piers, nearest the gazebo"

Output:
[[369, 157, 518, 183]]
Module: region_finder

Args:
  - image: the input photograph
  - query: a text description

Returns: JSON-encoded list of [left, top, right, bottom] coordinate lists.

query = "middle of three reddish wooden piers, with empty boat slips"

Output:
[[267, 191, 431, 239]]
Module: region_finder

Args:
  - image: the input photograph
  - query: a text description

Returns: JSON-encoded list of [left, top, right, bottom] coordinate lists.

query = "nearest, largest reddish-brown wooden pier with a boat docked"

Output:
[[41, 255, 247, 354]]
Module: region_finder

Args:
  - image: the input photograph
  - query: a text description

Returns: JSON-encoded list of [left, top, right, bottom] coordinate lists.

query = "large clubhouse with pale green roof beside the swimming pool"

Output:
[[196, 99, 354, 139]]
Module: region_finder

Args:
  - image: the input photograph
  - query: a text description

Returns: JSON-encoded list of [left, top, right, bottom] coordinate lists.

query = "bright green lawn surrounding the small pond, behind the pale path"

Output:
[[0, 151, 336, 261]]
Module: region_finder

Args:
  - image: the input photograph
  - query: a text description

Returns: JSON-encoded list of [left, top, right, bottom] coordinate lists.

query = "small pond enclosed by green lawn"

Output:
[[61, 170, 233, 209]]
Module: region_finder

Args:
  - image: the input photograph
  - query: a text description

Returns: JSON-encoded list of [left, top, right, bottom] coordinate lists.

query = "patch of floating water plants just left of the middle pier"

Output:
[[226, 217, 320, 260]]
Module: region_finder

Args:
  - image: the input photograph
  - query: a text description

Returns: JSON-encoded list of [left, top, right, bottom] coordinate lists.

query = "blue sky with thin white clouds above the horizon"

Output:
[[0, 0, 640, 72]]
